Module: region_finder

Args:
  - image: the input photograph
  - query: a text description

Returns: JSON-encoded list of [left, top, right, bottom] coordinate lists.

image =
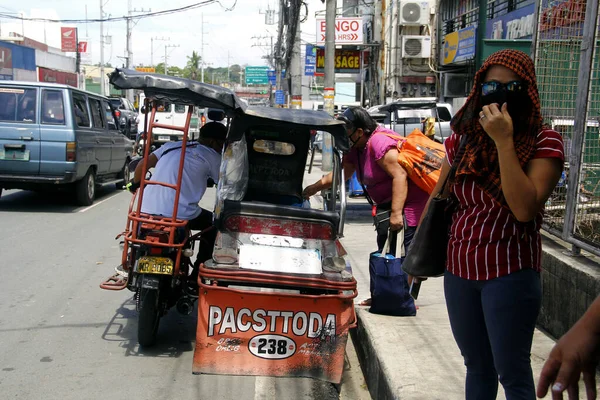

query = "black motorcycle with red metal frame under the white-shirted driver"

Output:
[[100, 70, 238, 346]]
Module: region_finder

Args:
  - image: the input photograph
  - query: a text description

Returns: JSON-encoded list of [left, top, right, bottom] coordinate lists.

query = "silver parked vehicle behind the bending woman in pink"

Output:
[[368, 97, 453, 143]]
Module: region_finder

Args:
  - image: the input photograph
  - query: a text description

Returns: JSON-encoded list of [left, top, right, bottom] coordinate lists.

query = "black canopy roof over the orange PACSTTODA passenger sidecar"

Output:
[[228, 106, 350, 151]]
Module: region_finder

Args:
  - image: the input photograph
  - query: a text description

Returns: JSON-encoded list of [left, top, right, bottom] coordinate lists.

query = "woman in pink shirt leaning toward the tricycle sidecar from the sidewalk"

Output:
[[303, 107, 429, 306]]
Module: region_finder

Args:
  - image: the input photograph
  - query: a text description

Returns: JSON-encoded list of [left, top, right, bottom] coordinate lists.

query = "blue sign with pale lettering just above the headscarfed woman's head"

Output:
[[485, 4, 535, 40]]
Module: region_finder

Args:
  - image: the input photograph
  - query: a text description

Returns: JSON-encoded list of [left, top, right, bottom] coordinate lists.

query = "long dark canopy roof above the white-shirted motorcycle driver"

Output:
[[110, 68, 246, 116]]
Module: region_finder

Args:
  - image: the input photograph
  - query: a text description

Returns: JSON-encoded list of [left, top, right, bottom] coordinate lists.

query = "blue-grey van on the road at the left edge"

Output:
[[0, 81, 133, 205]]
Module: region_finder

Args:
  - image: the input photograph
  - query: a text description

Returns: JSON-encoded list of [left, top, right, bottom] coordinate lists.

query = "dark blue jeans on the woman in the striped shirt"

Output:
[[444, 269, 542, 400]]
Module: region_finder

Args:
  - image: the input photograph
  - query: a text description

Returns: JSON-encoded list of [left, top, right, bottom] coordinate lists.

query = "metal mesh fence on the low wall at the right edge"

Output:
[[533, 0, 600, 255]]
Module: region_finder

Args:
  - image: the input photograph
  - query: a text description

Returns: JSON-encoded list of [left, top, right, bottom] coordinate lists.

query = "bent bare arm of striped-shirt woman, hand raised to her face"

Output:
[[480, 103, 562, 222]]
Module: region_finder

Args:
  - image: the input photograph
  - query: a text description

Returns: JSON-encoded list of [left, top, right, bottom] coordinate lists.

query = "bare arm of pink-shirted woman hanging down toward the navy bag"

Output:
[[377, 149, 408, 230]]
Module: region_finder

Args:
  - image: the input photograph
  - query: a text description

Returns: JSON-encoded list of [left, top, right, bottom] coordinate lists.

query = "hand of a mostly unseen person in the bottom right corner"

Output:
[[537, 296, 600, 399]]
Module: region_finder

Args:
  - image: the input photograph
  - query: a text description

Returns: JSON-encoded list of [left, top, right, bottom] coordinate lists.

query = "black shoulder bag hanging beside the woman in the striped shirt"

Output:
[[402, 135, 467, 277]]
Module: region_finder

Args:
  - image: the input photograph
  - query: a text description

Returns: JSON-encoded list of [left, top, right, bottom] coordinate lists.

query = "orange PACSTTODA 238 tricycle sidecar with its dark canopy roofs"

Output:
[[101, 70, 357, 384]]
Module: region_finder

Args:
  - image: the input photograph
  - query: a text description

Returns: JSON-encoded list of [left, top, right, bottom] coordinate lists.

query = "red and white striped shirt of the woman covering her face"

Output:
[[444, 129, 564, 280]]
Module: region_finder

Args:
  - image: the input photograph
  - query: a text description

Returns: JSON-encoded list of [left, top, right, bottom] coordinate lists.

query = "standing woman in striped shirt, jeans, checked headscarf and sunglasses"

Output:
[[432, 50, 564, 400]]
